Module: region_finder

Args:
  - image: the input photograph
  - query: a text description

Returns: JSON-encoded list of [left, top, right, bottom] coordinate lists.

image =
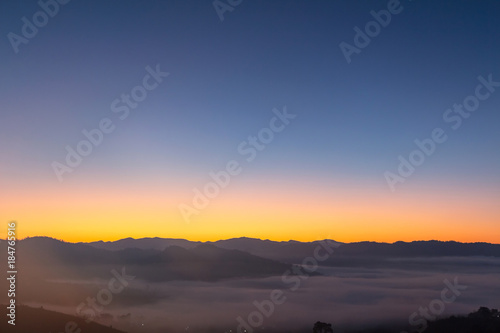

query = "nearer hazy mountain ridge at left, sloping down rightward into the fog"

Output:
[[8, 237, 291, 281]]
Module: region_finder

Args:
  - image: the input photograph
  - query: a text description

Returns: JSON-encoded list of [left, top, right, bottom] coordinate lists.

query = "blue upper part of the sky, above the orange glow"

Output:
[[0, 0, 500, 241]]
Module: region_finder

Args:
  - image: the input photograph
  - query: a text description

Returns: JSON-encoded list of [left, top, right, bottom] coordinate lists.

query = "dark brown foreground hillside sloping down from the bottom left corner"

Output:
[[0, 305, 123, 333]]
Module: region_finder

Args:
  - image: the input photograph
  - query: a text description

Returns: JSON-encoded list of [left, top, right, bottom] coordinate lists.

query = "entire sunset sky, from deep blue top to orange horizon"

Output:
[[0, 0, 500, 243]]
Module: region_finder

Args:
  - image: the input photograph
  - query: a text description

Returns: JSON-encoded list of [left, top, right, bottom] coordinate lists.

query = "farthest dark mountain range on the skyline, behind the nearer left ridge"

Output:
[[86, 237, 500, 263]]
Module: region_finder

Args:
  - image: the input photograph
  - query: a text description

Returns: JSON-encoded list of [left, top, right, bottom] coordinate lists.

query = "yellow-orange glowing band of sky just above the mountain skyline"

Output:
[[0, 176, 500, 243]]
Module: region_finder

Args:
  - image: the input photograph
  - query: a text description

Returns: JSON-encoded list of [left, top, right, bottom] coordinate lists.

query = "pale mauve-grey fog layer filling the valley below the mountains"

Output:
[[11, 258, 500, 332]]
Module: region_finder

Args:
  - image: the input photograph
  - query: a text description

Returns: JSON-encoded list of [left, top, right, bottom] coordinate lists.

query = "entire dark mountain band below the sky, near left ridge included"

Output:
[[3, 237, 500, 282]]
